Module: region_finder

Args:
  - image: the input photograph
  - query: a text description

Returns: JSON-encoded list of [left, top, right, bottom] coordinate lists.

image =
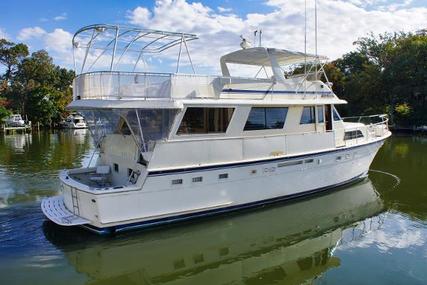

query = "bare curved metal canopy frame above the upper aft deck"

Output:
[[72, 24, 198, 73]]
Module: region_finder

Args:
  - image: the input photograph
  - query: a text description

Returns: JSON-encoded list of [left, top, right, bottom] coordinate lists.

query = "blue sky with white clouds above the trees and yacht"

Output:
[[0, 0, 427, 73]]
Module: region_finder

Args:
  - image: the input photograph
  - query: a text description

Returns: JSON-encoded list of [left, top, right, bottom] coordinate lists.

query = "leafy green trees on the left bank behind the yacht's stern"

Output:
[[0, 39, 75, 127]]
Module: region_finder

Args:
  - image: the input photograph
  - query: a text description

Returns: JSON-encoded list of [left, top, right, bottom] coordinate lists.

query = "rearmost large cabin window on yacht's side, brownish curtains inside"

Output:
[[177, 107, 234, 135]]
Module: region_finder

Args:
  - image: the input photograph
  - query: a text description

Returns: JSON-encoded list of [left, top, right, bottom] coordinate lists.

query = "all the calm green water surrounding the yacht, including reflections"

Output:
[[0, 132, 427, 284]]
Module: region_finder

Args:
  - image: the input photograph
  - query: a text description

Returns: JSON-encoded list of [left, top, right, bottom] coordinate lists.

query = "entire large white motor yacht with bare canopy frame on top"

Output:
[[41, 25, 391, 233]]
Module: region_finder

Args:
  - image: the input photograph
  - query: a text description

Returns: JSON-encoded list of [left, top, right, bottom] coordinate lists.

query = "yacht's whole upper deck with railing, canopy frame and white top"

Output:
[[72, 24, 345, 105]]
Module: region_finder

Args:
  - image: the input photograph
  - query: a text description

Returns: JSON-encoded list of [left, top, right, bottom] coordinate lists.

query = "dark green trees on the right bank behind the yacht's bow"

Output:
[[325, 31, 427, 127]]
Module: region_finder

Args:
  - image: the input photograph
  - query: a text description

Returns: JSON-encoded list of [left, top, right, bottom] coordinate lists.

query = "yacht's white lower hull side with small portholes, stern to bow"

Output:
[[41, 140, 384, 234]]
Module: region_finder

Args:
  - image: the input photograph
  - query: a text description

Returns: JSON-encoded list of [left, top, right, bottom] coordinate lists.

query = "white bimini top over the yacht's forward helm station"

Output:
[[221, 47, 328, 76]]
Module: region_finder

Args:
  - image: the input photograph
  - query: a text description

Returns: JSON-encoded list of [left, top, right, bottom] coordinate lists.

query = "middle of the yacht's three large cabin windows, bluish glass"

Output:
[[244, 107, 288, 131]]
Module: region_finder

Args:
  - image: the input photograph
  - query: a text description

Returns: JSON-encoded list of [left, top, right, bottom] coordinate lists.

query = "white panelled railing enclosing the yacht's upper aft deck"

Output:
[[73, 71, 265, 100]]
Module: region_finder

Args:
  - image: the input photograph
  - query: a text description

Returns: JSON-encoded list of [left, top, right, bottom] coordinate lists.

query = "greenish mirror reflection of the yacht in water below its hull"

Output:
[[44, 179, 383, 284]]
